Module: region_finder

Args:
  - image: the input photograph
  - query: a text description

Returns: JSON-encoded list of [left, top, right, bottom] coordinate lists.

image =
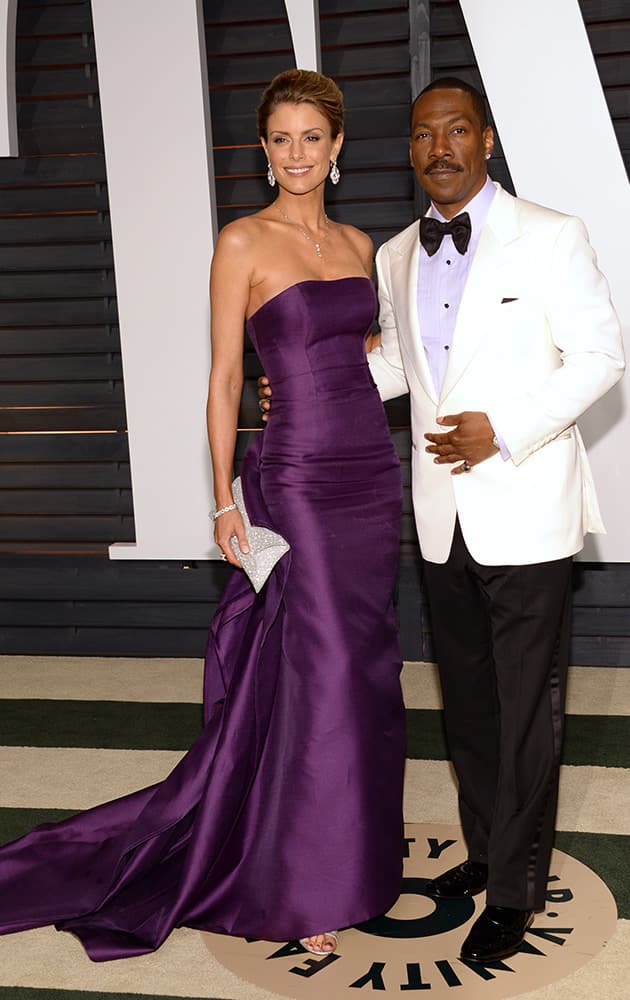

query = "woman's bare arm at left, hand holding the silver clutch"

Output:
[[207, 223, 250, 566]]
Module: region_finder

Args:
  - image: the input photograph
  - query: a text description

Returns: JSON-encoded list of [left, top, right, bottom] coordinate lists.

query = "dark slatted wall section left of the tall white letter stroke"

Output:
[[0, 0, 133, 552]]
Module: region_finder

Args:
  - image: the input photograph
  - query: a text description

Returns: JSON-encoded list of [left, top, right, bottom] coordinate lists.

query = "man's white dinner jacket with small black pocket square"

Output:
[[368, 185, 624, 565]]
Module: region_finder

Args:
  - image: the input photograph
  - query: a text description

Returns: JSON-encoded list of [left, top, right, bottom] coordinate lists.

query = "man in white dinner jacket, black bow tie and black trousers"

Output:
[[369, 78, 624, 962]]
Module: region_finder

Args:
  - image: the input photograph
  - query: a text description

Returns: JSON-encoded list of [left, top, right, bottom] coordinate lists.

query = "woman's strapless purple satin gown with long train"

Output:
[[0, 278, 405, 961]]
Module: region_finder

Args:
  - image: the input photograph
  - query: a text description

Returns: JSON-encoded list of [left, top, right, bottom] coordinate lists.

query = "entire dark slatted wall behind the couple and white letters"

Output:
[[0, 0, 630, 664]]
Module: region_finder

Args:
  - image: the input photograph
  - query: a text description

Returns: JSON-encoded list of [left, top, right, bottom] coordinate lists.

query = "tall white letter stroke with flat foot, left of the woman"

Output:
[[92, 0, 216, 559]]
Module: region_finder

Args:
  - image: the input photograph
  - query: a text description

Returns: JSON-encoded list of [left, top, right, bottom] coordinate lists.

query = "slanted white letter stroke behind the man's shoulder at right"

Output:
[[461, 0, 630, 562]]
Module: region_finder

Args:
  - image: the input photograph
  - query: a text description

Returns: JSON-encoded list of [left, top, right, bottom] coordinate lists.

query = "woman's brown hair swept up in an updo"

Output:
[[256, 69, 343, 142]]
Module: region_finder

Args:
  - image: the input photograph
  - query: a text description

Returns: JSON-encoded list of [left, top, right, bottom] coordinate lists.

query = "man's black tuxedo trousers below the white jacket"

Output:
[[424, 521, 571, 909]]
